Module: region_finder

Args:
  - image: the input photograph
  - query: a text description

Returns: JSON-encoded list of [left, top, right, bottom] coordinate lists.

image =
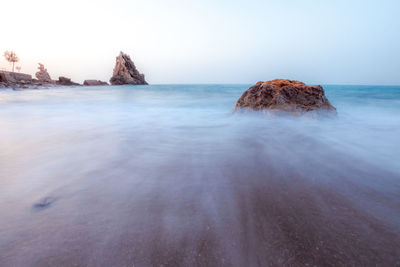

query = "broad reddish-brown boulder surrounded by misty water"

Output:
[[235, 79, 336, 112]]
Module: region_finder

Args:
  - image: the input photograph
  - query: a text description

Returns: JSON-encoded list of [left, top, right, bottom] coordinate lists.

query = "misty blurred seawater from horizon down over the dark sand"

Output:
[[0, 85, 400, 266]]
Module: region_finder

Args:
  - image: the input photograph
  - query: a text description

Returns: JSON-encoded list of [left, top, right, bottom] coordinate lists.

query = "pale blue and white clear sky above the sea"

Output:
[[0, 0, 400, 85]]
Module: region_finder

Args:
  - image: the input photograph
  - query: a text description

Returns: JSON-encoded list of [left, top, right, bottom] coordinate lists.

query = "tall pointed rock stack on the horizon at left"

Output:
[[110, 52, 148, 85]]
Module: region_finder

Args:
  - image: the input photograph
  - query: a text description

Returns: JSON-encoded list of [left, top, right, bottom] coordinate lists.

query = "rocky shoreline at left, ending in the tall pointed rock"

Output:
[[0, 52, 148, 89]]
